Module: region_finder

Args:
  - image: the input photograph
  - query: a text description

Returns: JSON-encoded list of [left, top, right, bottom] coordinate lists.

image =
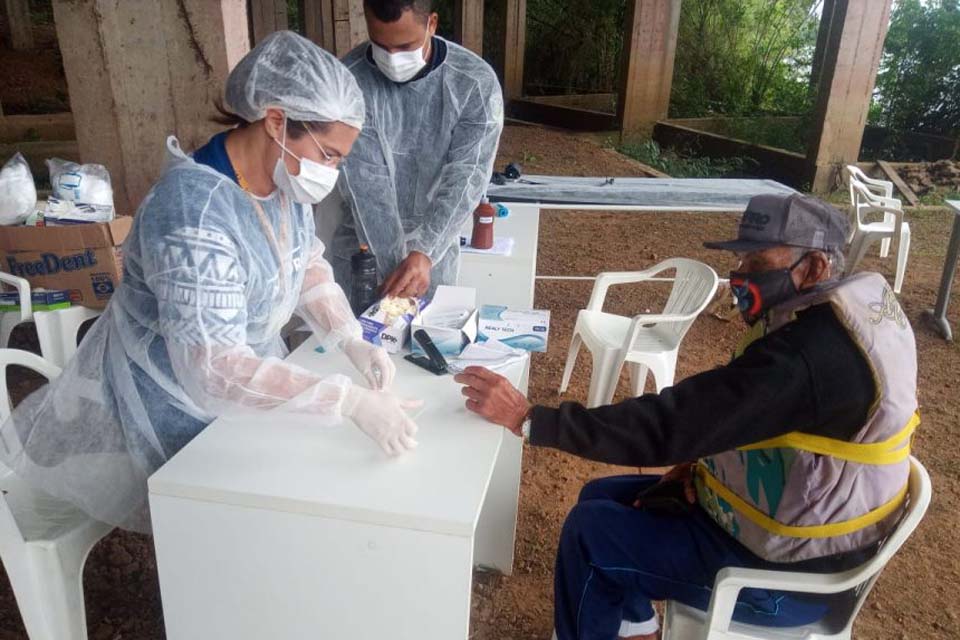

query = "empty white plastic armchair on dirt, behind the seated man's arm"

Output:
[[560, 258, 717, 407]]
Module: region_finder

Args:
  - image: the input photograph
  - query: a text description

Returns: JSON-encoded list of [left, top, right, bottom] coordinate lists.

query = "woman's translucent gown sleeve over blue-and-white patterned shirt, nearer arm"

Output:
[[148, 226, 351, 421]]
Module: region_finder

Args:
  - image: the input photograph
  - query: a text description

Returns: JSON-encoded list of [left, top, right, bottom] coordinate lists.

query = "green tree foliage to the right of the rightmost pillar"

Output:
[[871, 0, 960, 135]]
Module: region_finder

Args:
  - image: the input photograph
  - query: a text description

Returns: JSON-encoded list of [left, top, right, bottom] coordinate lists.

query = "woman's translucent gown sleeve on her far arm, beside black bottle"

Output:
[[297, 238, 363, 349]]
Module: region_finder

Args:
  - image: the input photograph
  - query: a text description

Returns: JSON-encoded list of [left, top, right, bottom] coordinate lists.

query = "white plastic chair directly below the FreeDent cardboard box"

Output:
[[0, 272, 103, 368]]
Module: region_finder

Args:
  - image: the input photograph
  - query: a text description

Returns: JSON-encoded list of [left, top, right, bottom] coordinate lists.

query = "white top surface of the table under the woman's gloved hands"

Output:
[[149, 340, 526, 536]]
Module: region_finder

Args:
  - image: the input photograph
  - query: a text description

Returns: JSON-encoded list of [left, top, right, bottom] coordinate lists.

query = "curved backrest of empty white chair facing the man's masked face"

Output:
[[627, 258, 719, 345]]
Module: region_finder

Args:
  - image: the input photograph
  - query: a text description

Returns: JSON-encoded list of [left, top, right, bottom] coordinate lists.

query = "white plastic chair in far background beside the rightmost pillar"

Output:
[[846, 176, 910, 294]]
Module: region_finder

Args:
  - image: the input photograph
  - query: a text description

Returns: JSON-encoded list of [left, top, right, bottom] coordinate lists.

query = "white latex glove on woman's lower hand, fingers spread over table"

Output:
[[342, 385, 423, 456]]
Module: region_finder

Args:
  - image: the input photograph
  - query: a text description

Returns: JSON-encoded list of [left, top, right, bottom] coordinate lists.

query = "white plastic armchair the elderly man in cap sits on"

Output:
[[663, 457, 932, 640]]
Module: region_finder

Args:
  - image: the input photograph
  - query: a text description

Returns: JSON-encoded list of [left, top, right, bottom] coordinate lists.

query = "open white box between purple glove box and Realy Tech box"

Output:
[[410, 285, 477, 356]]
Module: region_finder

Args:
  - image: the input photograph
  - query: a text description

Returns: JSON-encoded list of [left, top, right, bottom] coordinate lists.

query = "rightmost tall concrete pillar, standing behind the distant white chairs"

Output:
[[807, 0, 892, 193]]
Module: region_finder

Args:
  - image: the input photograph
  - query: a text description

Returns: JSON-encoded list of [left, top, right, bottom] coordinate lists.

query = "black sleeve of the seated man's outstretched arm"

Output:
[[530, 304, 876, 466]]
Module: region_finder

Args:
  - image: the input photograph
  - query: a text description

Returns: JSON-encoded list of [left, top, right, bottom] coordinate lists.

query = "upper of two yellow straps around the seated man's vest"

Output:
[[740, 413, 920, 465]]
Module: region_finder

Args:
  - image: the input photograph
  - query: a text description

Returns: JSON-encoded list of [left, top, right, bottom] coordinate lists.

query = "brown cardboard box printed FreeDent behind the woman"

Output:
[[0, 216, 133, 309]]
